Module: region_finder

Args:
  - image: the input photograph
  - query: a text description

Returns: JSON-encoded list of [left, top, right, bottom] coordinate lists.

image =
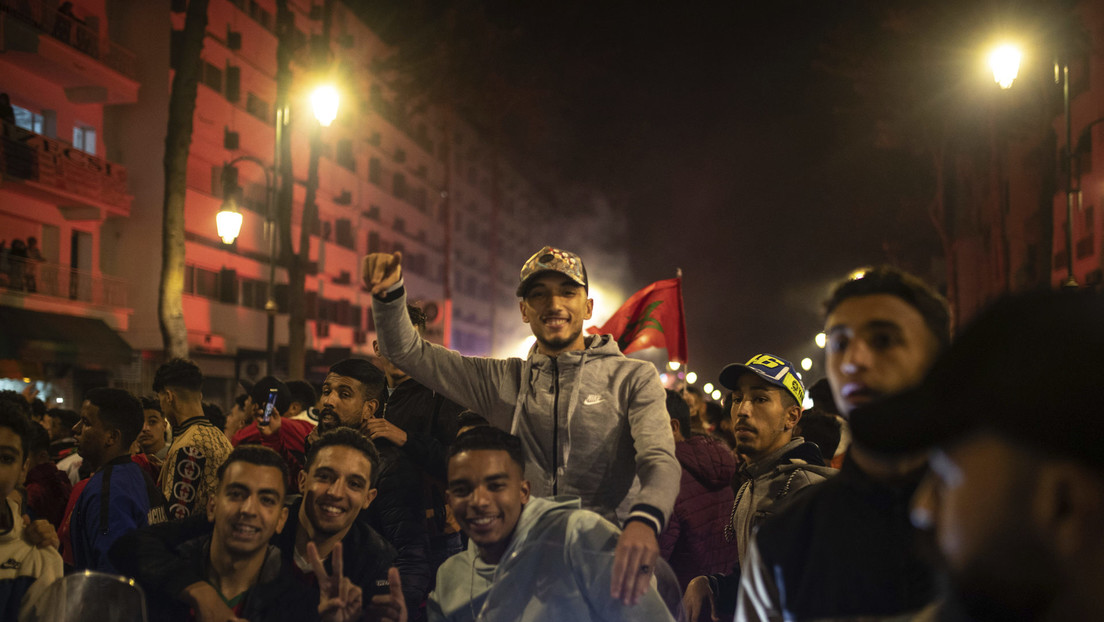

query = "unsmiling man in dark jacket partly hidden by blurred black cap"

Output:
[[736, 267, 951, 620]]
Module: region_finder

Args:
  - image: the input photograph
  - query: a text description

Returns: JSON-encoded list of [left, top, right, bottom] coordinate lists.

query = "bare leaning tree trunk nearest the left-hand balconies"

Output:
[[157, 0, 208, 358]]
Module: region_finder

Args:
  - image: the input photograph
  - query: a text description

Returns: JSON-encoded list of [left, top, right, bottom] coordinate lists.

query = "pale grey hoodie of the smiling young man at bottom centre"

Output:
[[428, 497, 672, 622]]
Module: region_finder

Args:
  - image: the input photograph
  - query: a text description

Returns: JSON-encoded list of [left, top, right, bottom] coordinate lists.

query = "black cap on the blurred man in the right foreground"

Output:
[[849, 292, 1104, 468]]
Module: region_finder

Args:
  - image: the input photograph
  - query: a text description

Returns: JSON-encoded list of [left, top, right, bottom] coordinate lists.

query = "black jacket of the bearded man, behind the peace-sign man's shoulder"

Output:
[[357, 439, 433, 609]]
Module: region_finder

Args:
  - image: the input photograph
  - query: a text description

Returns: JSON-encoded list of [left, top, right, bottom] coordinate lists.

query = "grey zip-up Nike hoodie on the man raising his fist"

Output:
[[372, 294, 682, 533]]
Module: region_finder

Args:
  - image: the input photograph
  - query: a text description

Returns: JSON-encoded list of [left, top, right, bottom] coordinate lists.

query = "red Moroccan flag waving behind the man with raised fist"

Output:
[[587, 278, 687, 362]]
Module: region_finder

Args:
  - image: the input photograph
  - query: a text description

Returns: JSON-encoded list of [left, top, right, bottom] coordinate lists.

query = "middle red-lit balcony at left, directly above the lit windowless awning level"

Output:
[[0, 123, 134, 220]]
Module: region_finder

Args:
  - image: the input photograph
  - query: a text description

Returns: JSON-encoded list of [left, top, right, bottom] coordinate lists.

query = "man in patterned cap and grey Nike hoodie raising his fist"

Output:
[[362, 246, 681, 604]]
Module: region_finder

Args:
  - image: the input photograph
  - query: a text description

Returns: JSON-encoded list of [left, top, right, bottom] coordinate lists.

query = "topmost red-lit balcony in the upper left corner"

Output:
[[0, 0, 138, 104]]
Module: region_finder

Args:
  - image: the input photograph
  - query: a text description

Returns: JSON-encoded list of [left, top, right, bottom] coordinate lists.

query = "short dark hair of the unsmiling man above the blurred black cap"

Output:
[[824, 265, 951, 352]]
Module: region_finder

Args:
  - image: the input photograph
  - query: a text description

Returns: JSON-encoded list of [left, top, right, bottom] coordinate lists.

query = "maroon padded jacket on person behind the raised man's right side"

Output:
[[659, 436, 736, 591]]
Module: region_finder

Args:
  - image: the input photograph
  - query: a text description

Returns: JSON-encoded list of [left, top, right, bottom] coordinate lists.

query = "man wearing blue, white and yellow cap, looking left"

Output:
[[683, 354, 835, 620]]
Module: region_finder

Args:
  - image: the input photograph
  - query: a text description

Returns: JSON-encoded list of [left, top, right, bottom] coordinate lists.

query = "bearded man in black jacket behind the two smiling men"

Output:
[[307, 358, 433, 615]]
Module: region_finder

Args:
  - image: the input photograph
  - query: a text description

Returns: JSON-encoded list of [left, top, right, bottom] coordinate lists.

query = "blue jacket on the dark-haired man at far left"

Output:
[[70, 455, 168, 574]]
